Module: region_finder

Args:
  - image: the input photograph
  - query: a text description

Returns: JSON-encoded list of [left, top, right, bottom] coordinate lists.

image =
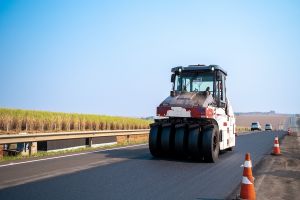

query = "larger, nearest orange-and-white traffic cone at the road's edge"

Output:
[[240, 153, 256, 200]]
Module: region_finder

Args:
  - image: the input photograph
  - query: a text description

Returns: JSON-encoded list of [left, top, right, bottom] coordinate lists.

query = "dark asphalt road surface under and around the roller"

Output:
[[0, 132, 284, 200]]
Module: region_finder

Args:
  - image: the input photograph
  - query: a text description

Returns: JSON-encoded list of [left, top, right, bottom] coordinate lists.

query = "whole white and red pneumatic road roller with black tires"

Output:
[[149, 65, 235, 162]]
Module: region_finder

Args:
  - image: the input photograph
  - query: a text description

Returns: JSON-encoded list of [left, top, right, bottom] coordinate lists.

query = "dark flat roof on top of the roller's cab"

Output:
[[171, 64, 227, 76]]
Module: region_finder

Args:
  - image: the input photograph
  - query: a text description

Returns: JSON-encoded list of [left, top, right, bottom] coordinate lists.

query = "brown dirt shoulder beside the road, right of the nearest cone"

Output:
[[228, 133, 300, 200]]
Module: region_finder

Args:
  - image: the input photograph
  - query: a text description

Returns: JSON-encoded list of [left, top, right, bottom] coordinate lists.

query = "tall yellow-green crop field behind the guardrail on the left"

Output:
[[0, 108, 152, 133]]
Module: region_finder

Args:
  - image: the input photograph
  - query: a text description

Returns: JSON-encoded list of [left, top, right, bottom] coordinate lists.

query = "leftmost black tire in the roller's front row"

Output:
[[149, 125, 161, 157]]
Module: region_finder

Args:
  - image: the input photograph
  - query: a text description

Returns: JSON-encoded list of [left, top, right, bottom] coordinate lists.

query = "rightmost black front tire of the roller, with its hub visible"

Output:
[[202, 126, 220, 162]]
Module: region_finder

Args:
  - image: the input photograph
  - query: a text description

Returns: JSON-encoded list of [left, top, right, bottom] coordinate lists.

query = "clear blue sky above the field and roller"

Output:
[[0, 0, 300, 117]]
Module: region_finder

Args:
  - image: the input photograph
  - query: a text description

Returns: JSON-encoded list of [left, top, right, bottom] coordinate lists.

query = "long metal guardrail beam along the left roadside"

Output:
[[0, 129, 150, 145]]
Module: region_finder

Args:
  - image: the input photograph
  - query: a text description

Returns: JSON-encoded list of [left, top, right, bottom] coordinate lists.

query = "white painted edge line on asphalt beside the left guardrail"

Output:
[[0, 144, 146, 168]]
